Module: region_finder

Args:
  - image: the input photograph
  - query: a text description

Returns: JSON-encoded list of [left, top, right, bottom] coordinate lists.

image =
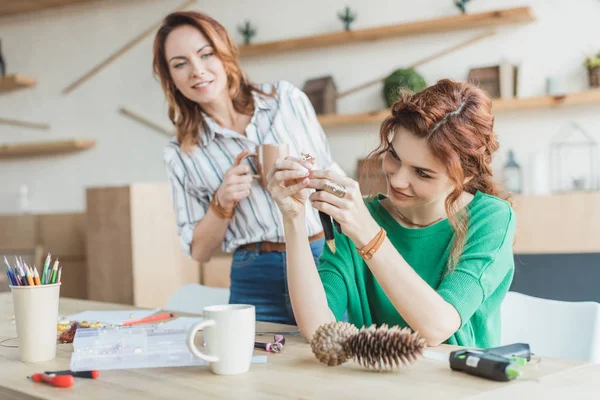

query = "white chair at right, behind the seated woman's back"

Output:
[[501, 292, 600, 363]]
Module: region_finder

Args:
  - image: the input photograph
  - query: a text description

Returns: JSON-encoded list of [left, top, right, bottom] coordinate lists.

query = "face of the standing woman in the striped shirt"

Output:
[[165, 25, 228, 105]]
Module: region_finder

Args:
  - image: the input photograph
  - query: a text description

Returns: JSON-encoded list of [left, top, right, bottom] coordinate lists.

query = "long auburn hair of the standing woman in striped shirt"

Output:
[[152, 11, 273, 151]]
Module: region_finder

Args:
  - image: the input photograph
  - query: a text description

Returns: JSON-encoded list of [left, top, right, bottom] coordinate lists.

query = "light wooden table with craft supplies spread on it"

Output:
[[0, 293, 600, 400]]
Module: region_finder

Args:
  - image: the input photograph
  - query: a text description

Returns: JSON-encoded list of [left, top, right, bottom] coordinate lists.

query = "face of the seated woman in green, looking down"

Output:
[[383, 127, 453, 209]]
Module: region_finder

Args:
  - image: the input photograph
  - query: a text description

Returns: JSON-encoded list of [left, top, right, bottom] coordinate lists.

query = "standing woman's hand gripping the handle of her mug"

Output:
[[215, 150, 253, 211]]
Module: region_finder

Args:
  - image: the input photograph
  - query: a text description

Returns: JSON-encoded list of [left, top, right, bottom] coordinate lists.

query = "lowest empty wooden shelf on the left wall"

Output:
[[0, 139, 96, 159]]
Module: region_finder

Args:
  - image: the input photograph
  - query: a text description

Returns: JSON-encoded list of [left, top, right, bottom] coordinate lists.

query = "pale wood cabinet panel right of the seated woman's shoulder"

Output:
[[514, 192, 600, 254]]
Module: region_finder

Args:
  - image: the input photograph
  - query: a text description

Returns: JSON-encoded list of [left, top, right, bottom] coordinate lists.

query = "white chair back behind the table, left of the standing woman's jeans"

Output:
[[165, 283, 229, 314]]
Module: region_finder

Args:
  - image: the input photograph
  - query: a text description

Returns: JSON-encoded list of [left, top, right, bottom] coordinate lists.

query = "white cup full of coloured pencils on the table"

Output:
[[4, 254, 62, 362]]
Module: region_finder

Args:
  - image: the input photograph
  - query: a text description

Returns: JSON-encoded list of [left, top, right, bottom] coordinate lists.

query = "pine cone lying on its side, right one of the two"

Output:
[[348, 324, 425, 371]]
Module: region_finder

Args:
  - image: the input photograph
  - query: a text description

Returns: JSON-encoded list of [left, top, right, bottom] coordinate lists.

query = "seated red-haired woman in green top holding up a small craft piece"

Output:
[[269, 80, 515, 348]]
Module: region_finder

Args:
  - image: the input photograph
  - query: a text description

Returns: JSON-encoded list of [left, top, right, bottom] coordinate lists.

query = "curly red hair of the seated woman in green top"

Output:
[[364, 79, 510, 270]]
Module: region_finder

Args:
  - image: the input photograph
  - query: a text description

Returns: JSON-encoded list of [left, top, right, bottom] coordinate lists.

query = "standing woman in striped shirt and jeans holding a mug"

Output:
[[153, 11, 339, 324]]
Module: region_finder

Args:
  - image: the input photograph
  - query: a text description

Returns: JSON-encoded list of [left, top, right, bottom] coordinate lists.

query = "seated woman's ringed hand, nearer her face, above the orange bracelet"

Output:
[[308, 170, 380, 249]]
